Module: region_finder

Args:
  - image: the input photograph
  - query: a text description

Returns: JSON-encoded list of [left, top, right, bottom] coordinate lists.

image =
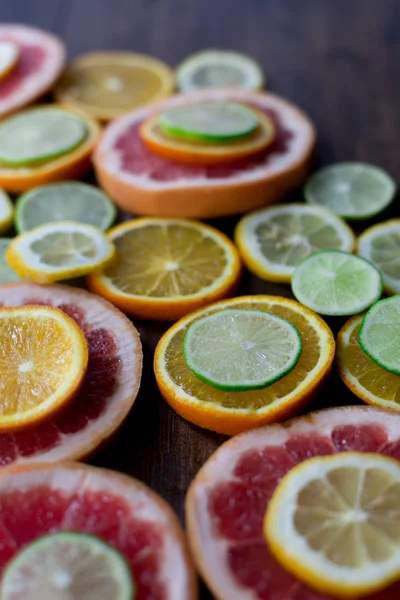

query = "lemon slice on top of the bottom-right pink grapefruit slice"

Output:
[[264, 452, 400, 598]]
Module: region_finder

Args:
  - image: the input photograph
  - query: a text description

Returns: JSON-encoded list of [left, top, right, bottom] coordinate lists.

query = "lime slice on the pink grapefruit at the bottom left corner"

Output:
[[1, 532, 136, 600]]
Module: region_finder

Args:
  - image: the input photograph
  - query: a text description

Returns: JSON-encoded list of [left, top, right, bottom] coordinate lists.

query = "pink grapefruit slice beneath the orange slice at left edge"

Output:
[[0, 283, 143, 466]]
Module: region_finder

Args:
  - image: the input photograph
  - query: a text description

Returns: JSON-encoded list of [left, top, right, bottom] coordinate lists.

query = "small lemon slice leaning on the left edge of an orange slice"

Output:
[[6, 221, 115, 283]]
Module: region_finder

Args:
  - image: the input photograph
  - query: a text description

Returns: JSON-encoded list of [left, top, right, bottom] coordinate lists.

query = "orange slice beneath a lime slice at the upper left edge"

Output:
[[0, 104, 100, 192]]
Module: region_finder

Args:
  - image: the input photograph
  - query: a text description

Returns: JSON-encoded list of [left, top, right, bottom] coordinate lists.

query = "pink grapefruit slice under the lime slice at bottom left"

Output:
[[0, 462, 197, 600]]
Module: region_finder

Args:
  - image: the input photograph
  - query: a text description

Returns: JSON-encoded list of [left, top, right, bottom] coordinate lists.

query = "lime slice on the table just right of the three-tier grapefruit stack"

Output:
[[304, 162, 396, 220]]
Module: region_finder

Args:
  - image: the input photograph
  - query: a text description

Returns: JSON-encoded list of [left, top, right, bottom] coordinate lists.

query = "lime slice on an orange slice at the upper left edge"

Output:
[[0, 108, 87, 167]]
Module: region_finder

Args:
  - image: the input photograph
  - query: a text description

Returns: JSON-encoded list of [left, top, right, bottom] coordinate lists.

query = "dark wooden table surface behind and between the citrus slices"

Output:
[[0, 0, 400, 599]]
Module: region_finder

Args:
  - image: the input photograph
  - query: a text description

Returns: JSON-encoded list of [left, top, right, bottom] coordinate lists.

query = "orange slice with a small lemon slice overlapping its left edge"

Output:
[[88, 219, 241, 320]]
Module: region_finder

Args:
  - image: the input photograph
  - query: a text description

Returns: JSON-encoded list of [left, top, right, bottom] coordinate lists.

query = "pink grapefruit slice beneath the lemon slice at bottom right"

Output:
[[186, 406, 400, 600]]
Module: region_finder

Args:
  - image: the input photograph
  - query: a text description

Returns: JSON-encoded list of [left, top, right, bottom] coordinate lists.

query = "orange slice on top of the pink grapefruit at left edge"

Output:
[[0, 306, 88, 433]]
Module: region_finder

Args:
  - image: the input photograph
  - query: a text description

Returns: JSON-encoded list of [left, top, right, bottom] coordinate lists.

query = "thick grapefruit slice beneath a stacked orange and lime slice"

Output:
[[94, 90, 315, 219]]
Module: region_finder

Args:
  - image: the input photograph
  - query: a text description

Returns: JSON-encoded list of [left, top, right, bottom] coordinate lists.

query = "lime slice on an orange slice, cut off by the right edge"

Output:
[[358, 295, 400, 375]]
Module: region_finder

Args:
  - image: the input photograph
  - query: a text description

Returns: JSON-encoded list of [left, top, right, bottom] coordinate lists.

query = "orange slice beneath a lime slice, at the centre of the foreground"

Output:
[[154, 296, 335, 435]]
